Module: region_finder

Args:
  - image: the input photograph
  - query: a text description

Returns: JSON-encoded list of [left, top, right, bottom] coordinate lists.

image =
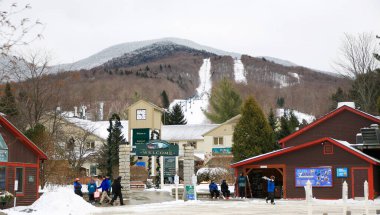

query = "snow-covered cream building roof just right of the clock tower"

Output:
[[161, 124, 219, 141]]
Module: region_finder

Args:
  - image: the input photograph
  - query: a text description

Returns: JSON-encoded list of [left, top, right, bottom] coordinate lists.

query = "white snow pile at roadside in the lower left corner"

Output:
[[4, 187, 98, 215]]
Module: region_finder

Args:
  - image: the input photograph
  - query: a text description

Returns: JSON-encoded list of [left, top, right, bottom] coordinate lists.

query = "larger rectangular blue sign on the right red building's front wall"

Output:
[[295, 167, 332, 187]]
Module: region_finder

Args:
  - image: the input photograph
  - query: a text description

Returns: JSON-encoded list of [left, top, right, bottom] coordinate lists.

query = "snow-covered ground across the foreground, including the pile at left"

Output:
[[1, 184, 380, 215]]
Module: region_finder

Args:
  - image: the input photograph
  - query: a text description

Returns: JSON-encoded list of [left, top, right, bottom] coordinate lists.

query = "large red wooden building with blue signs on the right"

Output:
[[231, 106, 380, 199]]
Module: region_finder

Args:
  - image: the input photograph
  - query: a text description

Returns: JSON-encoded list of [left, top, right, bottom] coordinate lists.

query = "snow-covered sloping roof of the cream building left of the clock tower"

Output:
[[64, 113, 128, 141]]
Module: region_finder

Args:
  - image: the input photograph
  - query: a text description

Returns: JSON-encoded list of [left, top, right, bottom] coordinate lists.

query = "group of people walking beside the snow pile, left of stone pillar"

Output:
[[74, 176, 124, 205]]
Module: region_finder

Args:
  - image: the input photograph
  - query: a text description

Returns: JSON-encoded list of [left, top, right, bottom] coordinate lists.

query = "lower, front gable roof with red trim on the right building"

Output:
[[231, 137, 380, 168]]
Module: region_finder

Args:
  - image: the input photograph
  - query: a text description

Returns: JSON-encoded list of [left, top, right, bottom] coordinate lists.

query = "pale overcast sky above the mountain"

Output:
[[7, 0, 380, 71]]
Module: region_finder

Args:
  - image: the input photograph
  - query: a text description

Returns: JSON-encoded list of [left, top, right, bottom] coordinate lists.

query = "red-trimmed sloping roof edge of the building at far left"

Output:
[[0, 115, 48, 160]]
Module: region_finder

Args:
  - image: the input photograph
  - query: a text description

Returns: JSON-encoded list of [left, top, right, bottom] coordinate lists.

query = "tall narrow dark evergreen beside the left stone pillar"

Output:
[[98, 113, 125, 178]]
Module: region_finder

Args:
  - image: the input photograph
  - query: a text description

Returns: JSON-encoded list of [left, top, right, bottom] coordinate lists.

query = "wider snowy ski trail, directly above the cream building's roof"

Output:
[[170, 59, 212, 124]]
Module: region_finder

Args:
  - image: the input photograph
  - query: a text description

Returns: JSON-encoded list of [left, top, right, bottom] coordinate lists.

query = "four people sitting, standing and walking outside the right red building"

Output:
[[209, 173, 275, 205]]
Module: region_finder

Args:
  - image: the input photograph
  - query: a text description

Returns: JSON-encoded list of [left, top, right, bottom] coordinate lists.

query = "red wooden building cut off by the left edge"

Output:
[[0, 116, 47, 205]]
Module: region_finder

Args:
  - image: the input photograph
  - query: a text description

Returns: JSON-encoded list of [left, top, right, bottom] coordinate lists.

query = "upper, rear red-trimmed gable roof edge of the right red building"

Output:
[[278, 105, 380, 143]]
